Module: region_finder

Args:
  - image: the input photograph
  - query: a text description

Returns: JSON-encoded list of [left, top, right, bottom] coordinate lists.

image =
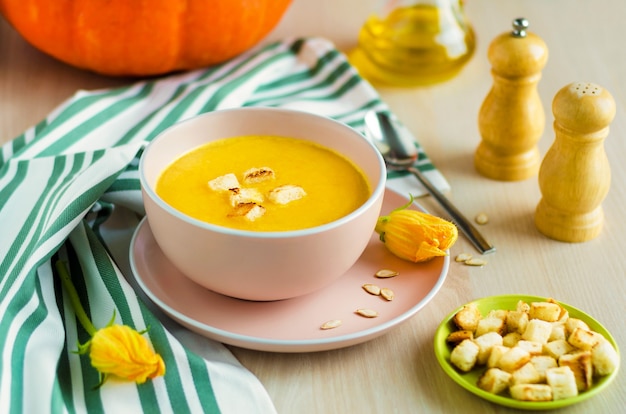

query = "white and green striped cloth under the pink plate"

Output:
[[0, 39, 447, 414]]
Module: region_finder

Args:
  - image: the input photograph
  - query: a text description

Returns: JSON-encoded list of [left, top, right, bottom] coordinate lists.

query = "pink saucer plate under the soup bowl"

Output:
[[130, 189, 450, 352]]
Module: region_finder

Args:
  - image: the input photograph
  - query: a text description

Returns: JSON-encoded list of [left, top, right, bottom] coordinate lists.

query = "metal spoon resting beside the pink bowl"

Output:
[[365, 111, 496, 254]]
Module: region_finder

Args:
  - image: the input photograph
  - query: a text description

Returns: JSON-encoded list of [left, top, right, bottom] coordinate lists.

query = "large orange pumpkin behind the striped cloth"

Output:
[[0, 0, 291, 76]]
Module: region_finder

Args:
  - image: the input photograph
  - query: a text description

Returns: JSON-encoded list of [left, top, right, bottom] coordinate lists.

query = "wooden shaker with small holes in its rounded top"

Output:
[[535, 82, 615, 242]]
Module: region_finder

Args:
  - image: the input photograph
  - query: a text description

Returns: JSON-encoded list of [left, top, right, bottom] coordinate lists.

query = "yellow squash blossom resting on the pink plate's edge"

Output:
[[376, 197, 459, 262]]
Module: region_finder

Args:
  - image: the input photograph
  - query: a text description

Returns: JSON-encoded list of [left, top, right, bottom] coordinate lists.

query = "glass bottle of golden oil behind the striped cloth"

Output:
[[349, 0, 475, 87]]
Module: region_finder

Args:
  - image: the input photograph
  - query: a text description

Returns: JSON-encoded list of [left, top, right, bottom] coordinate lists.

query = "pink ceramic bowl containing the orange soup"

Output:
[[139, 108, 386, 301]]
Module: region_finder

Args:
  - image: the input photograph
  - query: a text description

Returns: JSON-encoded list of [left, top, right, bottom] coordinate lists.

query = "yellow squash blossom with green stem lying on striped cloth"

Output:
[[56, 261, 165, 385]]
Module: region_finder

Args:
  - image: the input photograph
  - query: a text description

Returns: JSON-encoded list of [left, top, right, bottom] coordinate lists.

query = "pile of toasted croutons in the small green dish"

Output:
[[447, 299, 619, 401]]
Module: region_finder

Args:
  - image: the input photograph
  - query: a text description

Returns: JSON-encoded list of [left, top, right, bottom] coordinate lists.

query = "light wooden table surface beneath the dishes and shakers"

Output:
[[0, 0, 626, 414]]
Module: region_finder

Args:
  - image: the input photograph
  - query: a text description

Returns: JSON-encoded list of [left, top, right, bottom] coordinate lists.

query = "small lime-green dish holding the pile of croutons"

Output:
[[435, 295, 621, 410]]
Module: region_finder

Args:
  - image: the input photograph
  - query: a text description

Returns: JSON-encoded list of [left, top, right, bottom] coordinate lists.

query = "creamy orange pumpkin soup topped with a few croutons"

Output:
[[156, 136, 371, 231]]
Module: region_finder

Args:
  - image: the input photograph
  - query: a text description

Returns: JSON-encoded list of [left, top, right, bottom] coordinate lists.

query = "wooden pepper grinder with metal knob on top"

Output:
[[474, 18, 548, 181]]
